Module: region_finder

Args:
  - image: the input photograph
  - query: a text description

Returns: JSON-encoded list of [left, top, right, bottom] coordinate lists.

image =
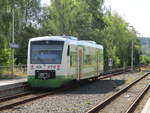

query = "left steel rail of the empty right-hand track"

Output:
[[86, 72, 150, 113]]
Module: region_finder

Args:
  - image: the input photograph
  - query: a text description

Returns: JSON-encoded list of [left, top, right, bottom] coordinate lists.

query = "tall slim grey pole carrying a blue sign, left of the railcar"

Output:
[[11, 8, 15, 78]]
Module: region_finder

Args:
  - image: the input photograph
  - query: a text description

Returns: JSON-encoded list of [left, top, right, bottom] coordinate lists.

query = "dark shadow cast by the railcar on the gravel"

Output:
[[63, 80, 125, 94]]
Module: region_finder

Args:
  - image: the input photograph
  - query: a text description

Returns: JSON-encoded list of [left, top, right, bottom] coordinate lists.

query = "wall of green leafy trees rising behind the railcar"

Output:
[[0, 0, 143, 69]]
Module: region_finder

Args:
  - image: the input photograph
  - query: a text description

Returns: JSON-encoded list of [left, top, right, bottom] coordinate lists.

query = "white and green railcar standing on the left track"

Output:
[[27, 36, 103, 88]]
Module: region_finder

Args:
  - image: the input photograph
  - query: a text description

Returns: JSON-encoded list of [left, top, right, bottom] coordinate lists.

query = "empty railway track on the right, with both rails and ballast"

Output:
[[86, 73, 150, 113]]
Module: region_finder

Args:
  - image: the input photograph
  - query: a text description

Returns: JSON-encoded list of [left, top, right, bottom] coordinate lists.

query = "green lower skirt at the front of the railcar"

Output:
[[28, 75, 73, 88]]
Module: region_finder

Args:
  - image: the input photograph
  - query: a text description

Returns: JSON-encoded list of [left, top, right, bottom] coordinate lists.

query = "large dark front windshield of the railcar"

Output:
[[30, 41, 64, 64]]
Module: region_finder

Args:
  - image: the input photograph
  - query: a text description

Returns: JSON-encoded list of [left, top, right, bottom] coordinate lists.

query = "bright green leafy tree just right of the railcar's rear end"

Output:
[[102, 11, 139, 69]]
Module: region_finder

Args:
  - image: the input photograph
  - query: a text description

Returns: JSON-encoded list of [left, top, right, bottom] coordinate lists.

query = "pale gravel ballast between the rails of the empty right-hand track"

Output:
[[100, 72, 150, 113]]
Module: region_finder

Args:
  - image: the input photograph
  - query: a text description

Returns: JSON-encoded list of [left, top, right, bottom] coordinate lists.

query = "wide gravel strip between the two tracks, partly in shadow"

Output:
[[3, 73, 144, 113]]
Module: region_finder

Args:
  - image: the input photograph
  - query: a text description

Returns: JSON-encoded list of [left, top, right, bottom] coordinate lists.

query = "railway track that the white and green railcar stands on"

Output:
[[0, 70, 132, 111]]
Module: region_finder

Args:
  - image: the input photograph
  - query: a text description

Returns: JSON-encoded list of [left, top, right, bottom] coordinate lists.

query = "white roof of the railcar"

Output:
[[29, 36, 103, 49]]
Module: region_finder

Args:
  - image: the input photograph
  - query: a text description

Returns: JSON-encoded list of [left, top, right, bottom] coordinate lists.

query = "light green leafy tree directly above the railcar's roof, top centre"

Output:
[[42, 0, 103, 40]]
